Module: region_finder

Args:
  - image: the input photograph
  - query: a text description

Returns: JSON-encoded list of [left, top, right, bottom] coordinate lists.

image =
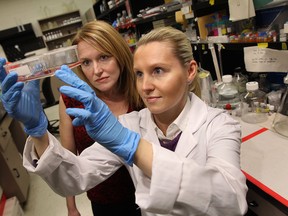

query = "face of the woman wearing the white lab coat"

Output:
[[134, 42, 196, 121]]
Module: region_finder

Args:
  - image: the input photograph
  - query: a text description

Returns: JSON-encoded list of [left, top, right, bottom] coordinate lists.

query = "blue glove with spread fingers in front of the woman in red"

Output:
[[55, 65, 140, 165]]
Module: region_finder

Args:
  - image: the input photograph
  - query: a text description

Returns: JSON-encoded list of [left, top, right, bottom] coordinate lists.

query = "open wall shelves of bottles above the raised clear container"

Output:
[[38, 11, 83, 50]]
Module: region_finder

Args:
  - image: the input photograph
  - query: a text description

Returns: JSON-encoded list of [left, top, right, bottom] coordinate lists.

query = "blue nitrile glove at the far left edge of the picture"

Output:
[[1, 72, 48, 137]]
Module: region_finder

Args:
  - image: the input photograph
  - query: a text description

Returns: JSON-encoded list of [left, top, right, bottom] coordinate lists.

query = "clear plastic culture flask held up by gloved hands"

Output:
[[4, 45, 80, 82]]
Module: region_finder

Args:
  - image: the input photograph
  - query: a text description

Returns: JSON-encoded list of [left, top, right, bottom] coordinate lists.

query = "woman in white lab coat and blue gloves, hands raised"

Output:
[[2, 27, 247, 216]]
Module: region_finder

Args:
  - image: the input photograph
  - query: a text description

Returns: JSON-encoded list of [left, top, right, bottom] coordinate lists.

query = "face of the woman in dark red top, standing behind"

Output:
[[77, 41, 120, 92]]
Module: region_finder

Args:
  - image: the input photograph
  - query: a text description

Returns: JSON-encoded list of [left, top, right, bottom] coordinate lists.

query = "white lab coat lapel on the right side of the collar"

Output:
[[175, 94, 208, 157]]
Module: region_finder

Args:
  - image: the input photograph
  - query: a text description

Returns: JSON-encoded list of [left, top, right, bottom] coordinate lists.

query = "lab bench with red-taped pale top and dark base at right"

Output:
[[236, 114, 288, 216]]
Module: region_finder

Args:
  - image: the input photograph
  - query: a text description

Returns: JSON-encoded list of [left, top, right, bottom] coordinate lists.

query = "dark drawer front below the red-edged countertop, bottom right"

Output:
[[247, 189, 287, 216]]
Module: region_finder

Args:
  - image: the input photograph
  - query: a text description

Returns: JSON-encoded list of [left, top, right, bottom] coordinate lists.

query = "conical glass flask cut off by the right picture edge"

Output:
[[272, 74, 288, 137]]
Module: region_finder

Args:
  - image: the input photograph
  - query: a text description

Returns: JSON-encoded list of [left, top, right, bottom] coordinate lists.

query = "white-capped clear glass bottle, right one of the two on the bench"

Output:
[[241, 81, 269, 124]]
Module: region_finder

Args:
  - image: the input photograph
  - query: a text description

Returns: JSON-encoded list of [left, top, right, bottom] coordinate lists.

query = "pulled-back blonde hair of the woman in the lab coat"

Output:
[[135, 27, 201, 97]]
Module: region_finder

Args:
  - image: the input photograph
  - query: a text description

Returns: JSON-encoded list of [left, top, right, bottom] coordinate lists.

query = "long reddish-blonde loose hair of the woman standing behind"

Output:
[[72, 20, 144, 110]]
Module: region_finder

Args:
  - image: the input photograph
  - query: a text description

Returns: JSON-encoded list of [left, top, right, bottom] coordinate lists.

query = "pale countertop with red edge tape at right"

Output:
[[238, 114, 288, 207]]
